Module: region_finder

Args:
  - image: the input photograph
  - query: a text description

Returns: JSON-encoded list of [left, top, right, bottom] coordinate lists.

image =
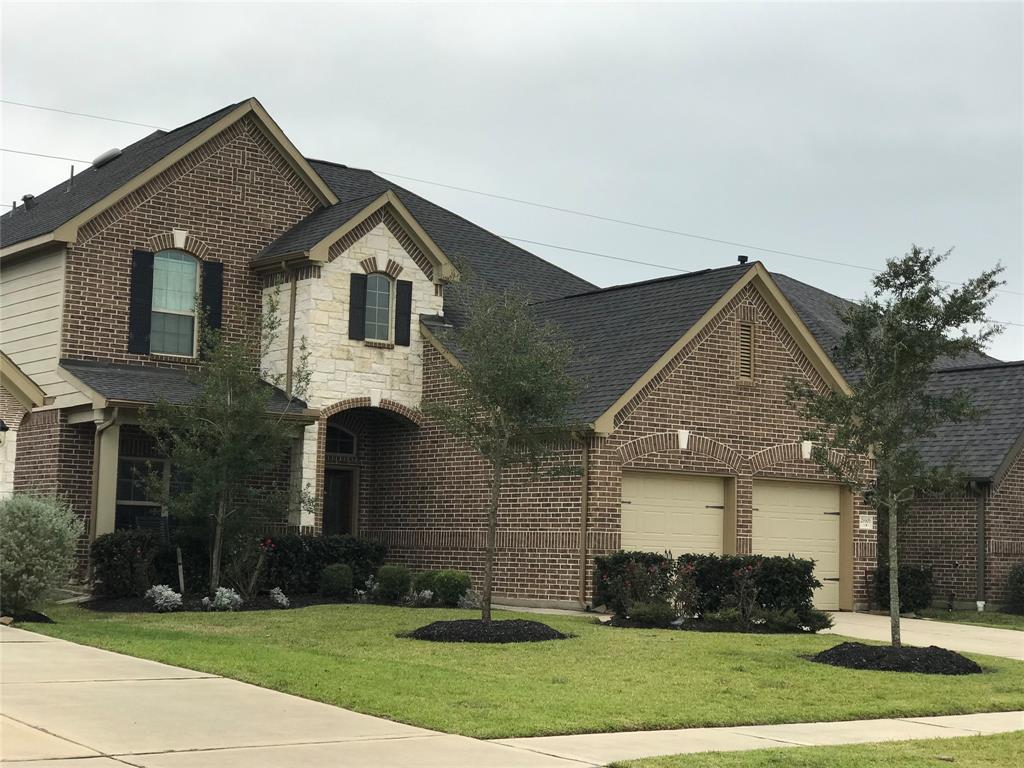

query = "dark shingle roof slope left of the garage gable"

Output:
[[535, 264, 753, 423]]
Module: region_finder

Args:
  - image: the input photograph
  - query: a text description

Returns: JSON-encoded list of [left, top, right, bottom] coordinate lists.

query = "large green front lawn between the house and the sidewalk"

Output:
[[23, 605, 1024, 738]]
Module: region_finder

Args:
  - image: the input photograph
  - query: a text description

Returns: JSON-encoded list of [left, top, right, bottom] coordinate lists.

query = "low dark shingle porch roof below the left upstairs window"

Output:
[[60, 359, 306, 415]]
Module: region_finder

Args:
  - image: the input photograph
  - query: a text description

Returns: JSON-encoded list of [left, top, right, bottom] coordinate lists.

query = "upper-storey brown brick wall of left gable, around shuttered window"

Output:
[[61, 118, 314, 365]]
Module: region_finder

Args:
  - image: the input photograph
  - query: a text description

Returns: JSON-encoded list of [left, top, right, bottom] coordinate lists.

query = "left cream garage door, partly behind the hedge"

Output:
[[622, 472, 725, 555]]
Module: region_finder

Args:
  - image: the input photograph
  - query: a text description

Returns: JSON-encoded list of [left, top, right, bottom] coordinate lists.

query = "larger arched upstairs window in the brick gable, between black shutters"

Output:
[[150, 251, 199, 357]]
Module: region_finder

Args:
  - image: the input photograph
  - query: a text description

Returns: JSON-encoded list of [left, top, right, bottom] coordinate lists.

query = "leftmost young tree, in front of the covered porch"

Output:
[[139, 295, 310, 595]]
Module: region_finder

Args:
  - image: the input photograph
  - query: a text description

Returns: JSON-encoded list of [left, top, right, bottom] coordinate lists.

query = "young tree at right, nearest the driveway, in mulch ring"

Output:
[[790, 246, 1002, 647]]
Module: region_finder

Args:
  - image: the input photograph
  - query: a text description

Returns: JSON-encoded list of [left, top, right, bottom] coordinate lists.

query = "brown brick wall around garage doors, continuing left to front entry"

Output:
[[359, 288, 876, 605]]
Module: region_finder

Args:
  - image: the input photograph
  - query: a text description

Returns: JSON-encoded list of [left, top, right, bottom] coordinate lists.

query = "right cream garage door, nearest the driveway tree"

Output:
[[753, 480, 839, 610]]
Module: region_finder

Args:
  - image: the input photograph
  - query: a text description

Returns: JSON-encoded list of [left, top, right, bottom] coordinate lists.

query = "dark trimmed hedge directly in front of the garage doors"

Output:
[[594, 552, 821, 615]]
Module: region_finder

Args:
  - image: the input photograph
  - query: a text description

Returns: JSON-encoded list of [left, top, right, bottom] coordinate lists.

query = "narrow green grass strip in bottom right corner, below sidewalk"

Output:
[[612, 731, 1024, 768]]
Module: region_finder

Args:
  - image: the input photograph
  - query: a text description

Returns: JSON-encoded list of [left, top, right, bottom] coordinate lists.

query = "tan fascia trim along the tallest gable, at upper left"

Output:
[[0, 98, 338, 264]]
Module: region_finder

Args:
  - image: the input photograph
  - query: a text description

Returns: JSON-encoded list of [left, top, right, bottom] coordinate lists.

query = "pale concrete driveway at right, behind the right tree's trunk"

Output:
[[830, 612, 1024, 660]]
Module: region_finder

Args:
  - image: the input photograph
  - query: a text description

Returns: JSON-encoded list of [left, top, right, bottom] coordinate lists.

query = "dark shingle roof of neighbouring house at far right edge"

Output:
[[919, 360, 1024, 480]]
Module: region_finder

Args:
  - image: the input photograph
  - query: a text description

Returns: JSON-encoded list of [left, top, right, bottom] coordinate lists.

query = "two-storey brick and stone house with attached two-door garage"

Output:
[[0, 99, 1022, 609]]
